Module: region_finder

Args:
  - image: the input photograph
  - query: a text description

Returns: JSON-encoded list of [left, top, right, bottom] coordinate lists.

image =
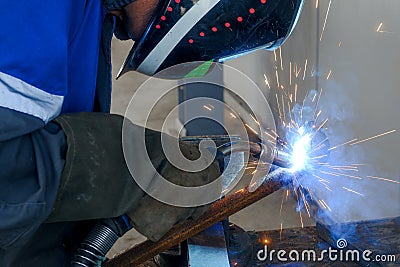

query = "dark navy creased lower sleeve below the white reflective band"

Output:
[[0, 108, 66, 250]]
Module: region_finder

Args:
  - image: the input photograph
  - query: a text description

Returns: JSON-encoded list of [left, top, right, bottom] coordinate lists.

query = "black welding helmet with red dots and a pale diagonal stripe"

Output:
[[118, 0, 304, 76]]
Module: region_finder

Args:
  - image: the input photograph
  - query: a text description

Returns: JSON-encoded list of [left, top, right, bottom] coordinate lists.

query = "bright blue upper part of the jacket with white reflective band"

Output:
[[0, 0, 104, 119]]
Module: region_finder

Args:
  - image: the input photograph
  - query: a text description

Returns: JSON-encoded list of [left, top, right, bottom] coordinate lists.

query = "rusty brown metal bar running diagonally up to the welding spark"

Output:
[[103, 169, 290, 267]]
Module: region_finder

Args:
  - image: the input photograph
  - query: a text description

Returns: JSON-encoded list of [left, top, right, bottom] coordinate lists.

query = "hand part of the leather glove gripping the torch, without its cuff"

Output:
[[127, 130, 221, 241]]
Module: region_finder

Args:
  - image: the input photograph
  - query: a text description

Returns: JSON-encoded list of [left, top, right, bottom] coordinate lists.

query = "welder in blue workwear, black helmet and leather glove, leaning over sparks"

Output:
[[0, 0, 302, 266]]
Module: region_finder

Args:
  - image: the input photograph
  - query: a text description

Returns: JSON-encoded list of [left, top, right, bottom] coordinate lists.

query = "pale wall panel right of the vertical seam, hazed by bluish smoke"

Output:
[[319, 0, 400, 222]]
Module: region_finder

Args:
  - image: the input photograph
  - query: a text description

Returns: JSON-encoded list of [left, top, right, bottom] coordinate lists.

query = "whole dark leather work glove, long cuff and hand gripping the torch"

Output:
[[47, 113, 221, 241]]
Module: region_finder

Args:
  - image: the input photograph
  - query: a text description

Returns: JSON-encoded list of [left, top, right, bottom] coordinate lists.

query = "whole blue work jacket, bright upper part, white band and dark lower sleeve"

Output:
[[0, 0, 113, 255]]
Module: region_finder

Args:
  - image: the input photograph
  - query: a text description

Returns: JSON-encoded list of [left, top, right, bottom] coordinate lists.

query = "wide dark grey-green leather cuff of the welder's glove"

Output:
[[48, 113, 144, 222]]
